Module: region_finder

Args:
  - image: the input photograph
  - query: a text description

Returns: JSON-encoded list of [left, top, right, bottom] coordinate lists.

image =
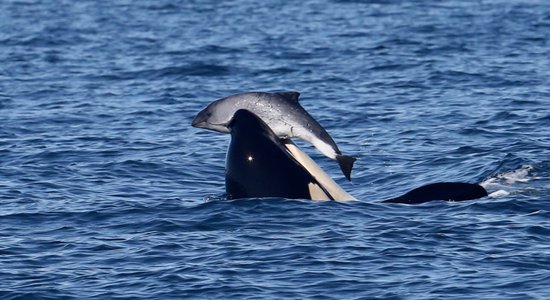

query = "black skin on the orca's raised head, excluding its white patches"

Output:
[[225, 109, 332, 199]]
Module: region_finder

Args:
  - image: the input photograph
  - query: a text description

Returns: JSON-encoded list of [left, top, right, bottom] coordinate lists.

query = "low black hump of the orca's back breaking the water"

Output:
[[383, 182, 487, 204]]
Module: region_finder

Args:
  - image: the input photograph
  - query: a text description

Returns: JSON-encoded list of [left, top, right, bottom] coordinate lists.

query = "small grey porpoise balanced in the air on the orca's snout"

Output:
[[191, 91, 356, 180]]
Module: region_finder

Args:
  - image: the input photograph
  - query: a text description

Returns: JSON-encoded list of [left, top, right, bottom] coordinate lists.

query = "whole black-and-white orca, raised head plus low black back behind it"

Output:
[[225, 109, 487, 204]]
